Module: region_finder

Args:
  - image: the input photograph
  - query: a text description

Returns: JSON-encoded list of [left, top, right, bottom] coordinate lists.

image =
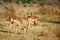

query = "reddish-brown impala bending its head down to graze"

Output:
[[9, 16, 26, 32]]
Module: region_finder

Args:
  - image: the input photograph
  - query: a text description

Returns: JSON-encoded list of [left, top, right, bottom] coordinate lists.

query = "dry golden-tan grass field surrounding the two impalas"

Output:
[[0, 3, 60, 40]]
